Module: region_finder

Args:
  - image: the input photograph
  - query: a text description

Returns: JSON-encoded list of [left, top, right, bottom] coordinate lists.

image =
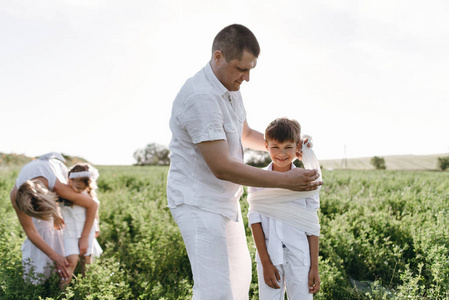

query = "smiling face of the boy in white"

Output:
[[265, 140, 299, 172]]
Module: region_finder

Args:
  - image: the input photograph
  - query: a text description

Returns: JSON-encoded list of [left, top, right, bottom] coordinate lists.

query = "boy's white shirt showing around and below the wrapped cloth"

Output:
[[248, 163, 320, 265]]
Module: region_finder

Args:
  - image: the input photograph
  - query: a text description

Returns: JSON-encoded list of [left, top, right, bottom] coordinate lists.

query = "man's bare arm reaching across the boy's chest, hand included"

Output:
[[197, 140, 323, 191]]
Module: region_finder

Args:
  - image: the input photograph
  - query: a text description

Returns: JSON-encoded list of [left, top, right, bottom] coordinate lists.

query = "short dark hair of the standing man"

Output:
[[212, 24, 260, 63]]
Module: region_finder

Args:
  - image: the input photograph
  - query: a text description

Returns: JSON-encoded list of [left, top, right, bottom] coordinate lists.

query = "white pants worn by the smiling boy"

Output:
[[257, 248, 313, 300]]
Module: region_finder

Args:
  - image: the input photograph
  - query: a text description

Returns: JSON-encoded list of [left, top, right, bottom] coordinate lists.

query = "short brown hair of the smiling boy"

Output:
[[265, 118, 301, 144]]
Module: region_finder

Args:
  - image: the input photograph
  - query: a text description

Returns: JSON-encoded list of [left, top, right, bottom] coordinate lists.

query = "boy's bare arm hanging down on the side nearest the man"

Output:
[[251, 223, 281, 289]]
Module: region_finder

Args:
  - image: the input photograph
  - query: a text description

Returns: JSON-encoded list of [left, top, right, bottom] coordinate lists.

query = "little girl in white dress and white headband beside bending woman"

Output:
[[60, 163, 103, 286]]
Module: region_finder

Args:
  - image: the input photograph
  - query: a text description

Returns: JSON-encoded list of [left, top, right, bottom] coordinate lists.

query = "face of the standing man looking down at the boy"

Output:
[[213, 51, 257, 91]]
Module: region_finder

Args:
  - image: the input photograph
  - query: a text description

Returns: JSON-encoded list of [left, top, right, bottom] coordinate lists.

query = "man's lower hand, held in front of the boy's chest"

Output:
[[285, 168, 323, 192]]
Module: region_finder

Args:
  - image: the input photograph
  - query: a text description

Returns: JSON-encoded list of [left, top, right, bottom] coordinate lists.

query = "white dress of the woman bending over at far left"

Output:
[[16, 152, 67, 284]]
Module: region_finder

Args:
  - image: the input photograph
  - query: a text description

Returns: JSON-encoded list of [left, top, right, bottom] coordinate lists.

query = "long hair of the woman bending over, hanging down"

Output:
[[16, 179, 58, 221]]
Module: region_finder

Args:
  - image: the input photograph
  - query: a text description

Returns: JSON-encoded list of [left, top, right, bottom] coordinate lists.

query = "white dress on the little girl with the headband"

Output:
[[60, 192, 103, 258]]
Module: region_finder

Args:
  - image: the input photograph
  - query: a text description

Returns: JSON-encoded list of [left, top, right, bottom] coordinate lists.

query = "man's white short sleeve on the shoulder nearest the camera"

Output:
[[179, 94, 226, 144]]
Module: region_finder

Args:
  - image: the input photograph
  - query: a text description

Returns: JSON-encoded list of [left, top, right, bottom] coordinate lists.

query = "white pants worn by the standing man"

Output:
[[170, 204, 251, 300]]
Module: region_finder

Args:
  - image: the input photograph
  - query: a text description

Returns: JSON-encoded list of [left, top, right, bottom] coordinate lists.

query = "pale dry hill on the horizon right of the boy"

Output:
[[320, 153, 449, 170]]
